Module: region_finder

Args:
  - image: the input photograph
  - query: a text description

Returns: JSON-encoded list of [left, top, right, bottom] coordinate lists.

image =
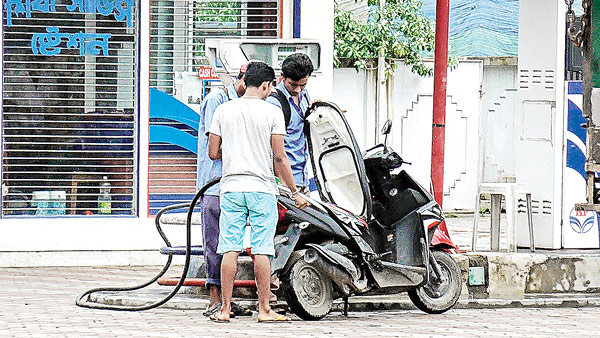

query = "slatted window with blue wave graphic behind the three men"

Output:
[[149, 0, 280, 214]]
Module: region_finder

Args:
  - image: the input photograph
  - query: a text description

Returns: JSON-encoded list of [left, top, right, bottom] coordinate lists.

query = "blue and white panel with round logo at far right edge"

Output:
[[562, 81, 600, 249]]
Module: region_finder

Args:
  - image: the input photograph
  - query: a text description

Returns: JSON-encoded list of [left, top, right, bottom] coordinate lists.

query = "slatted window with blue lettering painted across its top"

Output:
[[2, 0, 138, 217]]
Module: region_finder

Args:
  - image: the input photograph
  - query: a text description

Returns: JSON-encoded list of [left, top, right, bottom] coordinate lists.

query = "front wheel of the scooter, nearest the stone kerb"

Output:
[[408, 251, 461, 313]]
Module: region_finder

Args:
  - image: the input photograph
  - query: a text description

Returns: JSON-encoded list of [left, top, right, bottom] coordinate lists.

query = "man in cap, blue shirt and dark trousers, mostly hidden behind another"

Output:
[[196, 65, 247, 316]]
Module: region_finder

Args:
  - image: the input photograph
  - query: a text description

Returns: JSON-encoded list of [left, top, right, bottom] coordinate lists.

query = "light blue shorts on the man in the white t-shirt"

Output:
[[217, 192, 278, 256]]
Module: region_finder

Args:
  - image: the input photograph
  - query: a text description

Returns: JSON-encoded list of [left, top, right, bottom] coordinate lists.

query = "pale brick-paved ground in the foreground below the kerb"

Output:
[[5, 266, 600, 338]]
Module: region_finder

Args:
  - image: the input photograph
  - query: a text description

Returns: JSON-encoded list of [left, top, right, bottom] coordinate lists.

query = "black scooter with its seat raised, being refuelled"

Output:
[[271, 102, 461, 320]]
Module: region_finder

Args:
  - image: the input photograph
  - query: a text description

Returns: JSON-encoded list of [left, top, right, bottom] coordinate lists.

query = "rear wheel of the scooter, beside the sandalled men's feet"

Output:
[[282, 257, 333, 320]]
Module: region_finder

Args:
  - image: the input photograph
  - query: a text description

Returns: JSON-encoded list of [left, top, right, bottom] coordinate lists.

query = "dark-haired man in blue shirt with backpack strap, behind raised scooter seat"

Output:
[[267, 53, 314, 194]]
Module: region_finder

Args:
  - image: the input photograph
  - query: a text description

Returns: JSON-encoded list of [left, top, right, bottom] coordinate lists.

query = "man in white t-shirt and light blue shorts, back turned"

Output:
[[208, 62, 308, 322]]
